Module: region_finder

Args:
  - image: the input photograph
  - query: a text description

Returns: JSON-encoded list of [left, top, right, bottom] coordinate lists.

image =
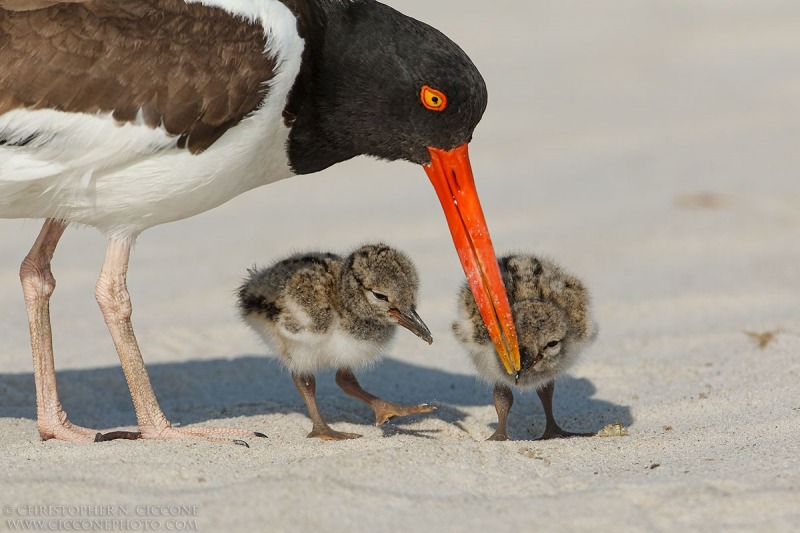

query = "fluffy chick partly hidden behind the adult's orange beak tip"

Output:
[[453, 254, 597, 440]]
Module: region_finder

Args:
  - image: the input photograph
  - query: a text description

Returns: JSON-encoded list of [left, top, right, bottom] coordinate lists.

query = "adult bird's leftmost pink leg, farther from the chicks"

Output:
[[19, 220, 125, 442]]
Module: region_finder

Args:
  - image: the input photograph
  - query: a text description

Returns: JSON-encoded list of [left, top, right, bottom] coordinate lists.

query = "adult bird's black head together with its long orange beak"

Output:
[[288, 1, 519, 374]]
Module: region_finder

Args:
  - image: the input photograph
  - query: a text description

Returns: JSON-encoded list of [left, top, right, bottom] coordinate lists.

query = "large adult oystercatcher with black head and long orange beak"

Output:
[[0, 0, 519, 441]]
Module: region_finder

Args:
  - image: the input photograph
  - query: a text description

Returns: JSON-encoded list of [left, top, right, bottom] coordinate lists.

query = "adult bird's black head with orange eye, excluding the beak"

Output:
[[289, 2, 487, 173]]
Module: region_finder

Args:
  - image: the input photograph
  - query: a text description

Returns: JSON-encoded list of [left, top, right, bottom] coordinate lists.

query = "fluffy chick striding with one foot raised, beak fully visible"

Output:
[[238, 243, 434, 440]]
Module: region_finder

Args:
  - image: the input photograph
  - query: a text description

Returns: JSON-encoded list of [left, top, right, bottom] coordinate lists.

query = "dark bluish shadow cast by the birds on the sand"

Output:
[[0, 355, 633, 439]]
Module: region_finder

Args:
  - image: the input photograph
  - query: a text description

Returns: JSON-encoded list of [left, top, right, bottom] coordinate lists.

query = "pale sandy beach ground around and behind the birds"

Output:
[[0, 0, 800, 532]]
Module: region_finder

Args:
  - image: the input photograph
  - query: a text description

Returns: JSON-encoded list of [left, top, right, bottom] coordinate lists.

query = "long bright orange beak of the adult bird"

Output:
[[423, 144, 520, 374]]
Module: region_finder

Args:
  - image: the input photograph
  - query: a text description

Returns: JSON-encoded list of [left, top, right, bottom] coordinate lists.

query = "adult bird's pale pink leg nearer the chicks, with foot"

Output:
[[95, 238, 264, 445]]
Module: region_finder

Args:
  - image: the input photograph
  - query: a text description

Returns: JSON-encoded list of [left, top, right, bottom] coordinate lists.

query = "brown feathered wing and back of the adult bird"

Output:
[[0, 0, 276, 152]]
